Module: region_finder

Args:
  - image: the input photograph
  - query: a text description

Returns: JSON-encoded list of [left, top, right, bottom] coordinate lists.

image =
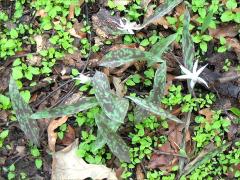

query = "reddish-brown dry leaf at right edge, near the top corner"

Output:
[[209, 24, 239, 38]]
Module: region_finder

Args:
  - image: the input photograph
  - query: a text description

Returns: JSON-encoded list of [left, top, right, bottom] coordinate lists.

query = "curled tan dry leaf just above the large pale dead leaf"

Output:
[[47, 116, 68, 152]]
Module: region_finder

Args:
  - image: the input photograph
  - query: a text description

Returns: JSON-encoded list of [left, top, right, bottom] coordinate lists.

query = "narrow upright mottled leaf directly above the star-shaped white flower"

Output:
[[182, 10, 195, 71]]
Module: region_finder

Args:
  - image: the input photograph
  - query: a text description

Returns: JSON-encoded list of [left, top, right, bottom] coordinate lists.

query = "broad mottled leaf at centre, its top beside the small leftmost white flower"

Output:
[[92, 71, 129, 123]]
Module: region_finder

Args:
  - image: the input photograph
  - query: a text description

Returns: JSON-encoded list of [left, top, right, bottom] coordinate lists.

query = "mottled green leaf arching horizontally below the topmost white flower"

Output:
[[100, 48, 159, 68]]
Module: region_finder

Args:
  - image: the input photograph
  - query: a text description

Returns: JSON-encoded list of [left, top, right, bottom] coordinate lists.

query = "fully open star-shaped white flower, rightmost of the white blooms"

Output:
[[175, 61, 208, 89]]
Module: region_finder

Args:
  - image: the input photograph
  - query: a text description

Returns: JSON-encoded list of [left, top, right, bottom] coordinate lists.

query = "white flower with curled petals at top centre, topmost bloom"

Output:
[[114, 18, 142, 34]]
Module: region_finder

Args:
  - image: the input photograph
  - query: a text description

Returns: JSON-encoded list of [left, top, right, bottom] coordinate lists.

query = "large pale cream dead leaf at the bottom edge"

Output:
[[51, 139, 117, 180]]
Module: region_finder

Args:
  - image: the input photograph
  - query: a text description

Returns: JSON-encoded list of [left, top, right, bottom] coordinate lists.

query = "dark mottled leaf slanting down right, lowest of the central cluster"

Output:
[[96, 114, 130, 162]]
